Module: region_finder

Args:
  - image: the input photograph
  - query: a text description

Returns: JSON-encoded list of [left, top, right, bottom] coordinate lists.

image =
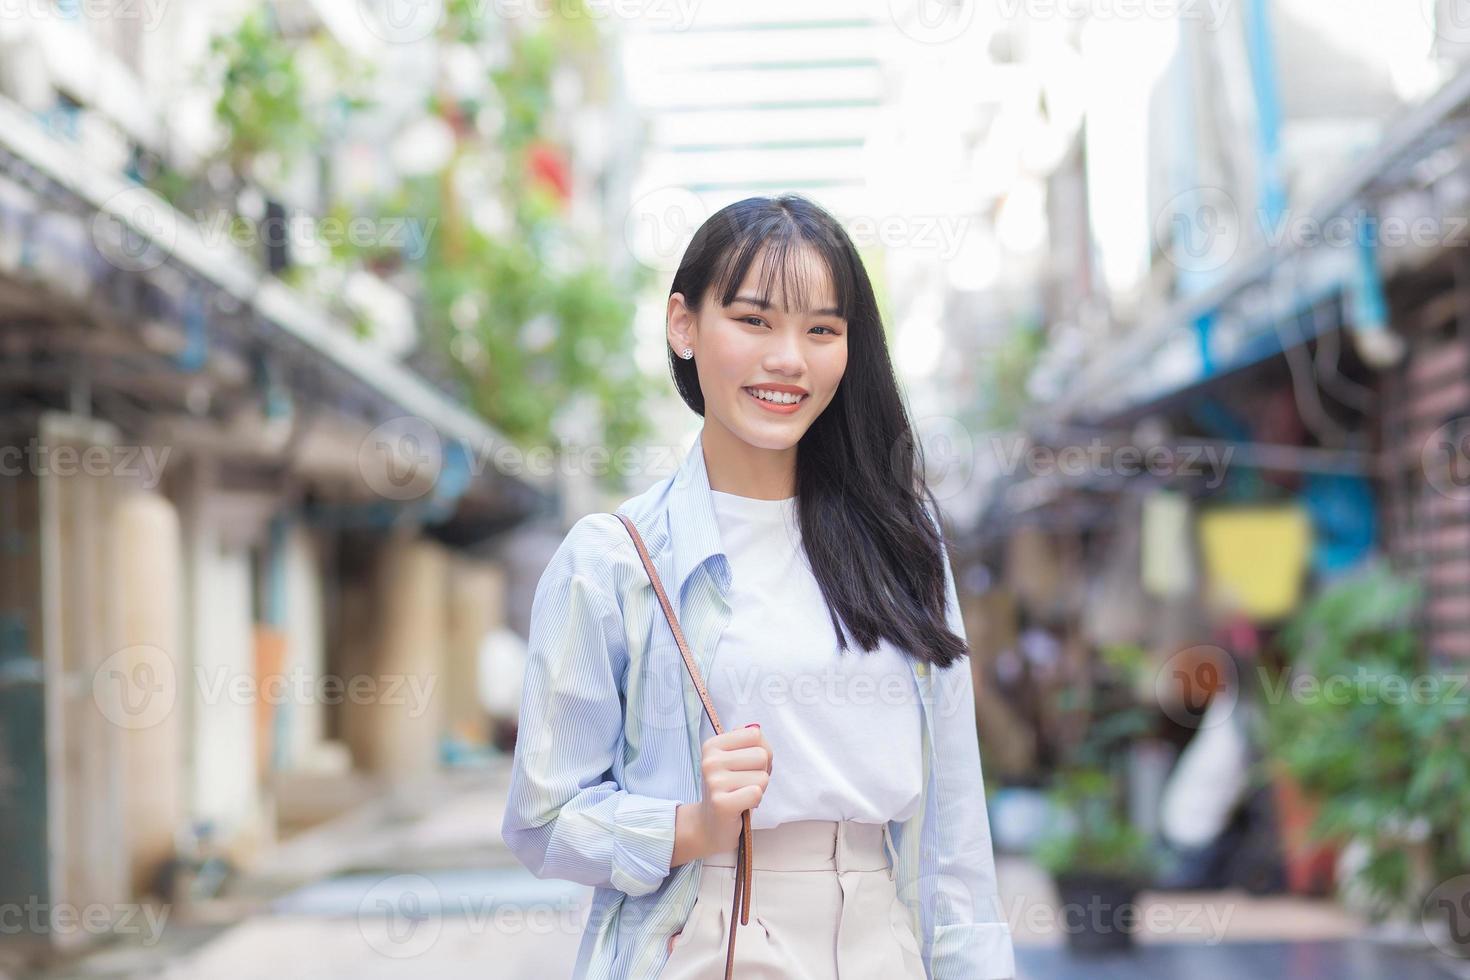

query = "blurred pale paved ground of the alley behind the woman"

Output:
[[14, 763, 1470, 980]]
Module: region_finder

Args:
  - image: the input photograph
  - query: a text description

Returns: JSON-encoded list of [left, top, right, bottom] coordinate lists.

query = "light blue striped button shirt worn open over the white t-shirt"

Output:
[[501, 438, 1014, 980]]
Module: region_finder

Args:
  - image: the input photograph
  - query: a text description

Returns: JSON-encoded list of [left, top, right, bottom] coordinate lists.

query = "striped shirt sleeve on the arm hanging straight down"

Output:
[[926, 514, 1016, 980]]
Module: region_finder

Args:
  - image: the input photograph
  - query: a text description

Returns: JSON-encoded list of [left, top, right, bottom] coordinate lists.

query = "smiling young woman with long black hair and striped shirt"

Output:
[[503, 195, 1014, 980]]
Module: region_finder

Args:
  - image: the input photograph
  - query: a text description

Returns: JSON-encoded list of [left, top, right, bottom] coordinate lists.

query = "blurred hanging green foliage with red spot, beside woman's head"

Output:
[[426, 4, 648, 461]]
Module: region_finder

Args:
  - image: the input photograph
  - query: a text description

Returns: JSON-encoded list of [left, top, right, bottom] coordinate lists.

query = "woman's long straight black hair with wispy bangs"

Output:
[[669, 194, 969, 667]]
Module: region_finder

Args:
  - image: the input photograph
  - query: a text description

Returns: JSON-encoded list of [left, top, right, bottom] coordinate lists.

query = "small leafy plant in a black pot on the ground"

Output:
[[1035, 768, 1154, 954]]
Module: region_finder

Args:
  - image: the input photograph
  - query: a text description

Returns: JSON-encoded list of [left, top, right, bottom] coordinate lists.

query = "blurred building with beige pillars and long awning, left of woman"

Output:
[[0, 3, 614, 963]]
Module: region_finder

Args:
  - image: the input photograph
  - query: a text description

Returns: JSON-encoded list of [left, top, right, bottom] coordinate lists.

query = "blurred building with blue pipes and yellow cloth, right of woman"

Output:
[[961, 1, 1470, 910]]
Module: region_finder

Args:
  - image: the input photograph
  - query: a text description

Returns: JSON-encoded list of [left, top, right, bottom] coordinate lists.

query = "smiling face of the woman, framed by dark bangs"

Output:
[[667, 248, 848, 450]]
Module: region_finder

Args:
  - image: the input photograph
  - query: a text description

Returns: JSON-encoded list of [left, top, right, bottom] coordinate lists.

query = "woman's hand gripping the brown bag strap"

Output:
[[672, 723, 772, 865]]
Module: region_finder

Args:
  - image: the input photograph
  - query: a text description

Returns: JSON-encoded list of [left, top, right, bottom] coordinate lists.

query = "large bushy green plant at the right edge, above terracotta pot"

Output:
[[1263, 564, 1470, 915]]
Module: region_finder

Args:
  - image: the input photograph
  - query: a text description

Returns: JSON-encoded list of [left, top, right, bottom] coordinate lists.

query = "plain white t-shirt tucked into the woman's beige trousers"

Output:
[[700, 491, 923, 827]]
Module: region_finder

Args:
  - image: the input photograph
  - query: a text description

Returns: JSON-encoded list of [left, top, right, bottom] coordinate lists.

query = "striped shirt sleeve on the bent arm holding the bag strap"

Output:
[[501, 516, 679, 895]]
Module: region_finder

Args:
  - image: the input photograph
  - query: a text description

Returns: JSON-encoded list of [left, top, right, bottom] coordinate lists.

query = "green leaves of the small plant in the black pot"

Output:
[[1033, 768, 1154, 880]]
